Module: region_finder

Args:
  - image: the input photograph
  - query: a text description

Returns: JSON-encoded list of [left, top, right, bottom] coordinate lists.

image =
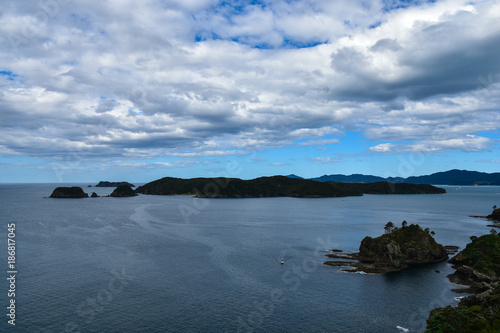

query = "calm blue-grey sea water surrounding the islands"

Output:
[[0, 184, 500, 332]]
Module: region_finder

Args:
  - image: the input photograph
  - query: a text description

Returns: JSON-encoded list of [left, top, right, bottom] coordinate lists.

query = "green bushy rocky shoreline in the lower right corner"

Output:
[[426, 232, 500, 332]]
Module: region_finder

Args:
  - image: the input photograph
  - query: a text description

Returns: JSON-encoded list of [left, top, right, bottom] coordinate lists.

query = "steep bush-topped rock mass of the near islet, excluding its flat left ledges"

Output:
[[358, 224, 448, 270]]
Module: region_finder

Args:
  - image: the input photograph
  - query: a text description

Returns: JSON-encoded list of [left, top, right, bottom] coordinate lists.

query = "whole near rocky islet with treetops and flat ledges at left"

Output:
[[324, 221, 448, 273]]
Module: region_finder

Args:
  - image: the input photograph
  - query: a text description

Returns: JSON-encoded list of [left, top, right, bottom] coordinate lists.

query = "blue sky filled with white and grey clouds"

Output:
[[0, 0, 500, 184]]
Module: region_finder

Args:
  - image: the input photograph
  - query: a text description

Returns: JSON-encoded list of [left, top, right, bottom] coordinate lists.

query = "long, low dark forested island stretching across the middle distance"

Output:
[[136, 176, 446, 198]]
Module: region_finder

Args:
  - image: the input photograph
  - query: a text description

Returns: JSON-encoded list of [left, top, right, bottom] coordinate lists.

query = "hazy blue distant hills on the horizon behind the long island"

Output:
[[291, 169, 500, 185]]
